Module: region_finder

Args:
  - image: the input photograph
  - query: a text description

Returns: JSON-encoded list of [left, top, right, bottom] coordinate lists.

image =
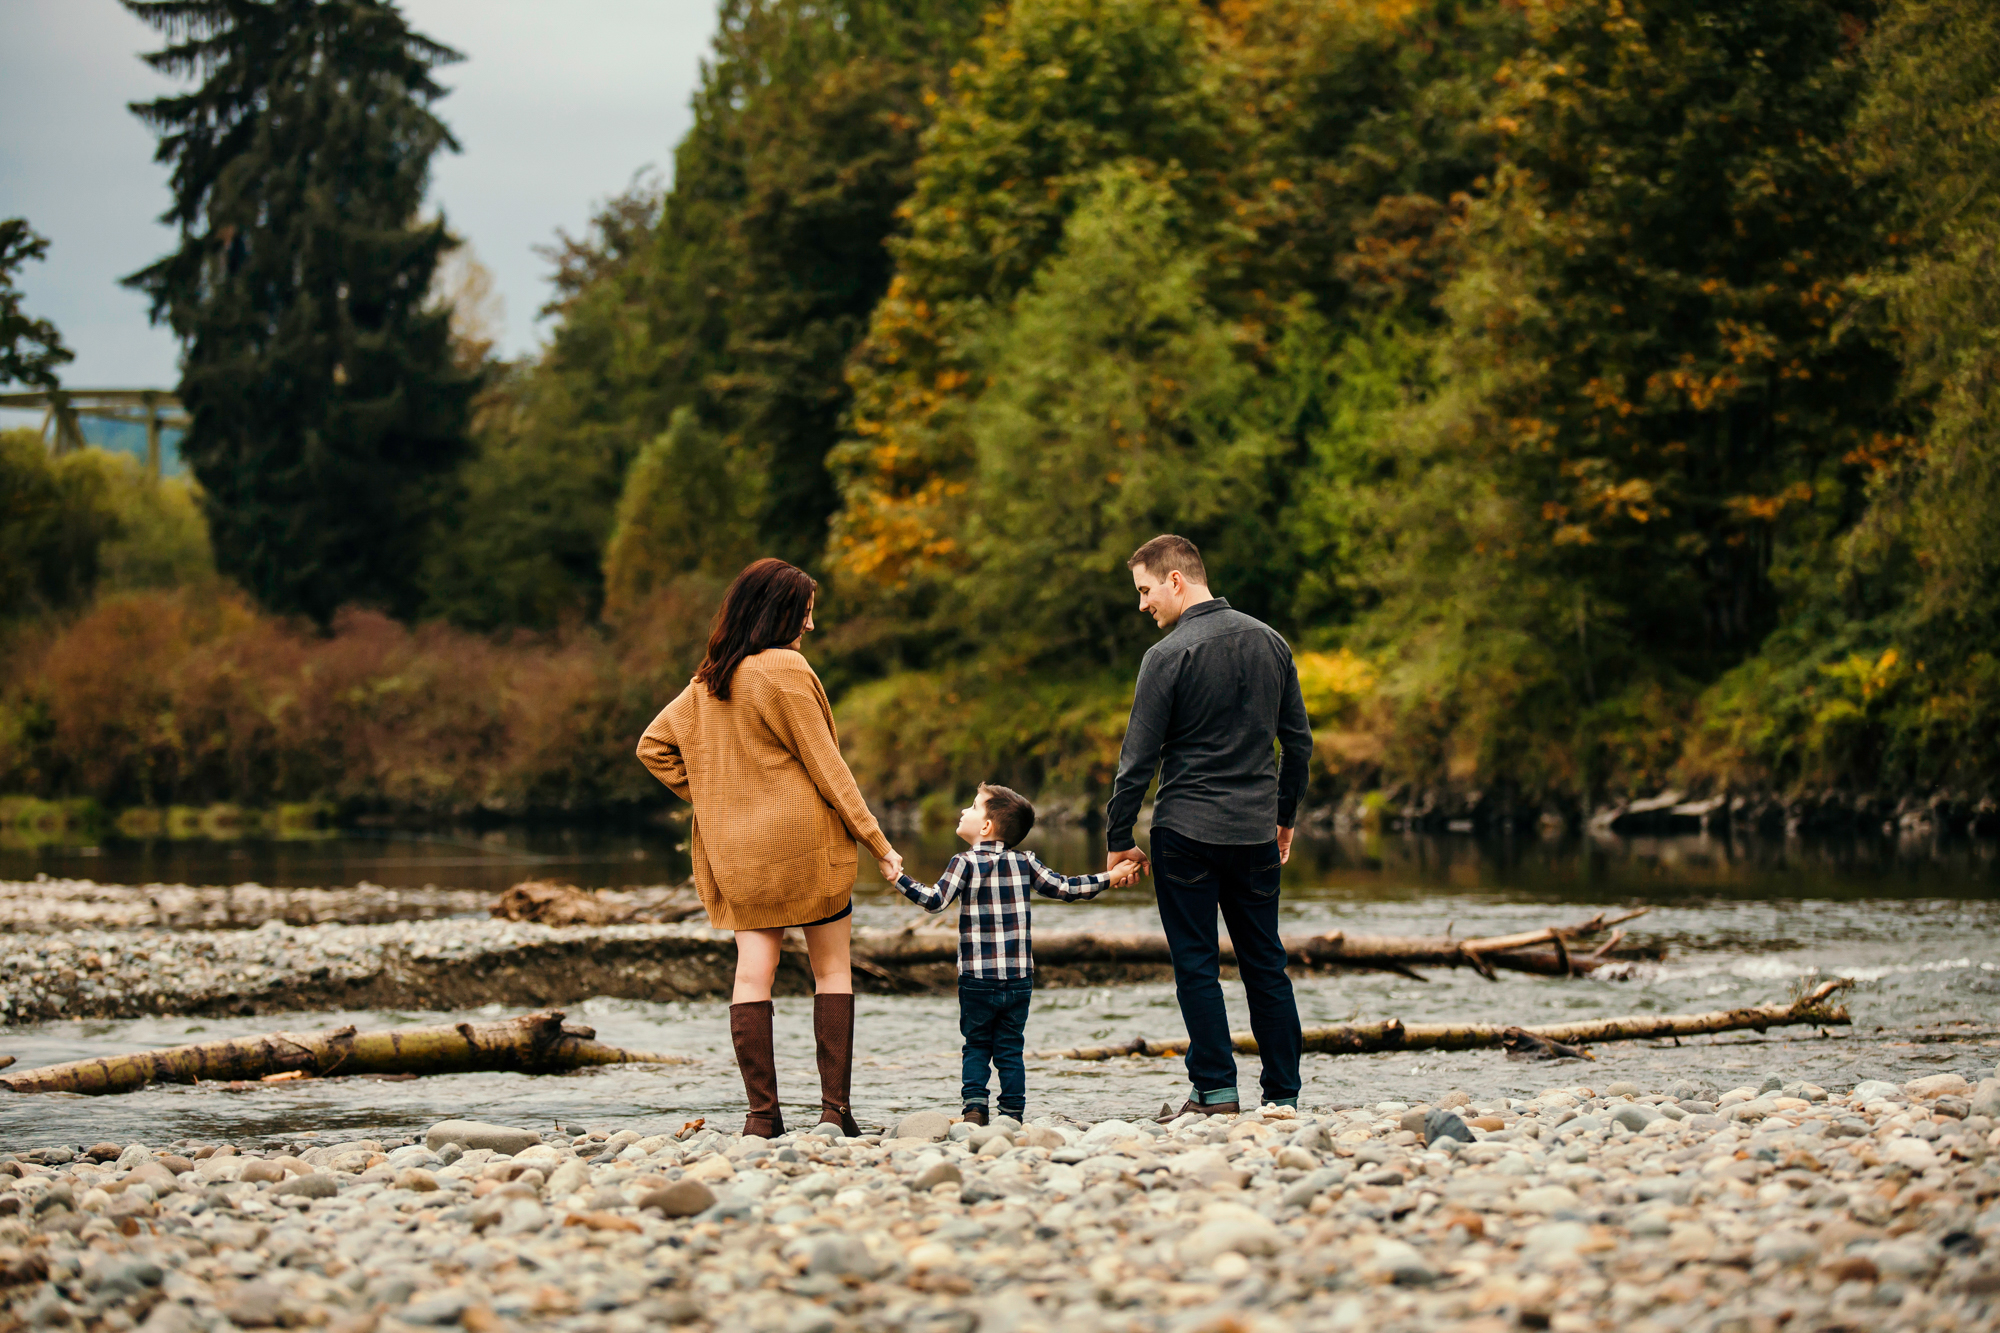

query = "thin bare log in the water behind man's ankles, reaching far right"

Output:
[[1036, 979, 1854, 1061]]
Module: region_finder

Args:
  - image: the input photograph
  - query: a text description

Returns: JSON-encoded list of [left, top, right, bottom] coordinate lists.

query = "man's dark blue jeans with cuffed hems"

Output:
[[1152, 827, 1302, 1101]]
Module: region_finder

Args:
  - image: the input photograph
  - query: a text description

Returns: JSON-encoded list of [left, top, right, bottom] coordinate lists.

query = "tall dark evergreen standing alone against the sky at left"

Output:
[[122, 0, 474, 620]]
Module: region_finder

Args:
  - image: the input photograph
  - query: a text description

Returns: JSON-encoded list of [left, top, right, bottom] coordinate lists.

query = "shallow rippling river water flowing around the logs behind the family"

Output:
[[0, 831, 2000, 1151]]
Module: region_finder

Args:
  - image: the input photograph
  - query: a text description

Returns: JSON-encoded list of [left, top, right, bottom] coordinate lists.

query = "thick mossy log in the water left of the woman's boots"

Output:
[[0, 1011, 688, 1093]]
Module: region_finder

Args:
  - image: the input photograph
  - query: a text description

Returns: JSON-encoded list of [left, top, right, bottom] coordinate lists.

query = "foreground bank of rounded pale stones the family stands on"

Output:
[[0, 1071, 2000, 1333]]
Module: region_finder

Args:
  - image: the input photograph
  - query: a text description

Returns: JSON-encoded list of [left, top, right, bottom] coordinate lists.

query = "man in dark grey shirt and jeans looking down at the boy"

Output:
[[1104, 534, 1312, 1121]]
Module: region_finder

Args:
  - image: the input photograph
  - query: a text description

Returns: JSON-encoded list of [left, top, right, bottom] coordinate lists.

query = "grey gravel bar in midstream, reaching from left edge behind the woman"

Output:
[[0, 881, 1662, 1023]]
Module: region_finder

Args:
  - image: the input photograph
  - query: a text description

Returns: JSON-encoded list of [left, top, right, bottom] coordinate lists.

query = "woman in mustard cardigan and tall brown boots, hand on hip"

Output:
[[638, 560, 902, 1139]]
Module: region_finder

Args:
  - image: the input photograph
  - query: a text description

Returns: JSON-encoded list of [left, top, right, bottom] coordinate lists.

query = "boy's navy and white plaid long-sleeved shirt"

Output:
[[896, 841, 1112, 981]]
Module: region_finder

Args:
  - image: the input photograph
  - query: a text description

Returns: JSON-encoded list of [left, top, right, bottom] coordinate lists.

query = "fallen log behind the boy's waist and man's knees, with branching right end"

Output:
[[854, 907, 1648, 979]]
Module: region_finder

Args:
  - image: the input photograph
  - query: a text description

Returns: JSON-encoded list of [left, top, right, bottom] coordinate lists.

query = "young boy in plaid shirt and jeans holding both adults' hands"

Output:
[[896, 783, 1138, 1125]]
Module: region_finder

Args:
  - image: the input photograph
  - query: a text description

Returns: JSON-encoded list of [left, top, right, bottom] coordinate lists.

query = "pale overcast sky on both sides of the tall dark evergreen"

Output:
[[0, 0, 716, 400]]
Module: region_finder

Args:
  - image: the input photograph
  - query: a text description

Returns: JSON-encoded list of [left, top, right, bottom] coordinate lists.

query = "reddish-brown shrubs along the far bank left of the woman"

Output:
[[0, 584, 732, 815]]
